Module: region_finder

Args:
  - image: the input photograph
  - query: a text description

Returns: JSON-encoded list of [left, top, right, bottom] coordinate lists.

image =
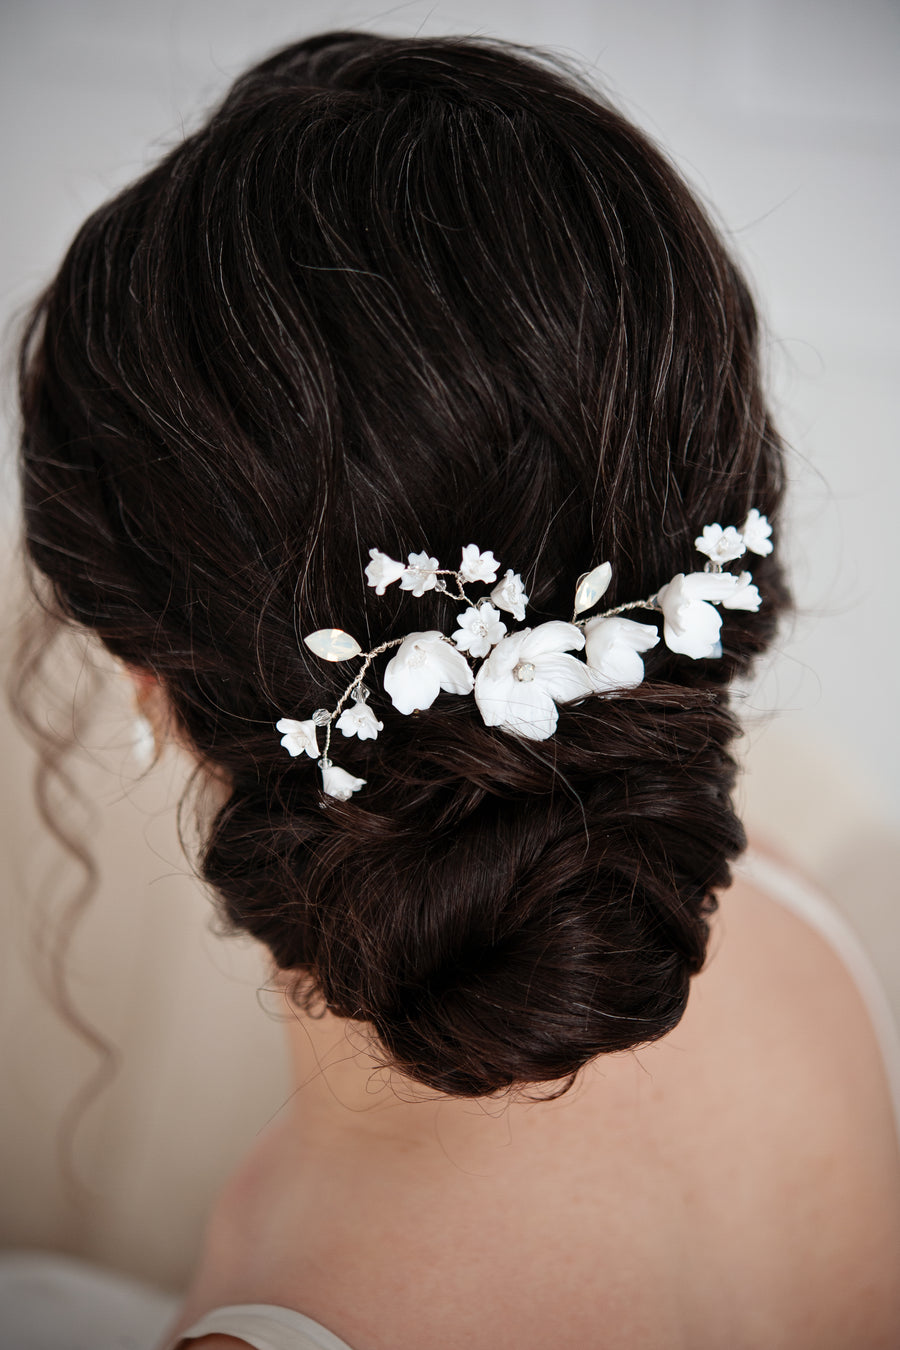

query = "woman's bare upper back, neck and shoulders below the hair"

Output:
[[165, 864, 900, 1350]]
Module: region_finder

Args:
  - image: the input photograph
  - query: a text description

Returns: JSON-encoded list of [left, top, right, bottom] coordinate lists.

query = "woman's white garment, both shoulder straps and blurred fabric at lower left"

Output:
[[0, 852, 900, 1350]]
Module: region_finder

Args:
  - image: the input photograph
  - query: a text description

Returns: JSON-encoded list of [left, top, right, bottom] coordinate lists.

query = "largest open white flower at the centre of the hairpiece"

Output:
[[475, 620, 592, 741]]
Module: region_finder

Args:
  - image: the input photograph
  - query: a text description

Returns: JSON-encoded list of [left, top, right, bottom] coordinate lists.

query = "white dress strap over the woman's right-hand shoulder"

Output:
[[734, 849, 900, 1142]]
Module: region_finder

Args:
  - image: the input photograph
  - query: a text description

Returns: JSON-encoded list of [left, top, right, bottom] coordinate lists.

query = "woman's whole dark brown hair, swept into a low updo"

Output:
[[14, 32, 788, 1096]]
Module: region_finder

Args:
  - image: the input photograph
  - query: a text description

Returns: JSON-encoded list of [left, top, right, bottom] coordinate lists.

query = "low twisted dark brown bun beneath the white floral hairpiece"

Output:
[[205, 684, 745, 1096]]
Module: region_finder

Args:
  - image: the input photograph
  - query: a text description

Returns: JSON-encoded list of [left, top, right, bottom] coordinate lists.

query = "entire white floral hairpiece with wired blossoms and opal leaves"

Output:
[[275, 509, 772, 801]]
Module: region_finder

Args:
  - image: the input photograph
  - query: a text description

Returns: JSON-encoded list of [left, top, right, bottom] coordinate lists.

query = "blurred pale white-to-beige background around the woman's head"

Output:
[[0, 0, 900, 1287]]
